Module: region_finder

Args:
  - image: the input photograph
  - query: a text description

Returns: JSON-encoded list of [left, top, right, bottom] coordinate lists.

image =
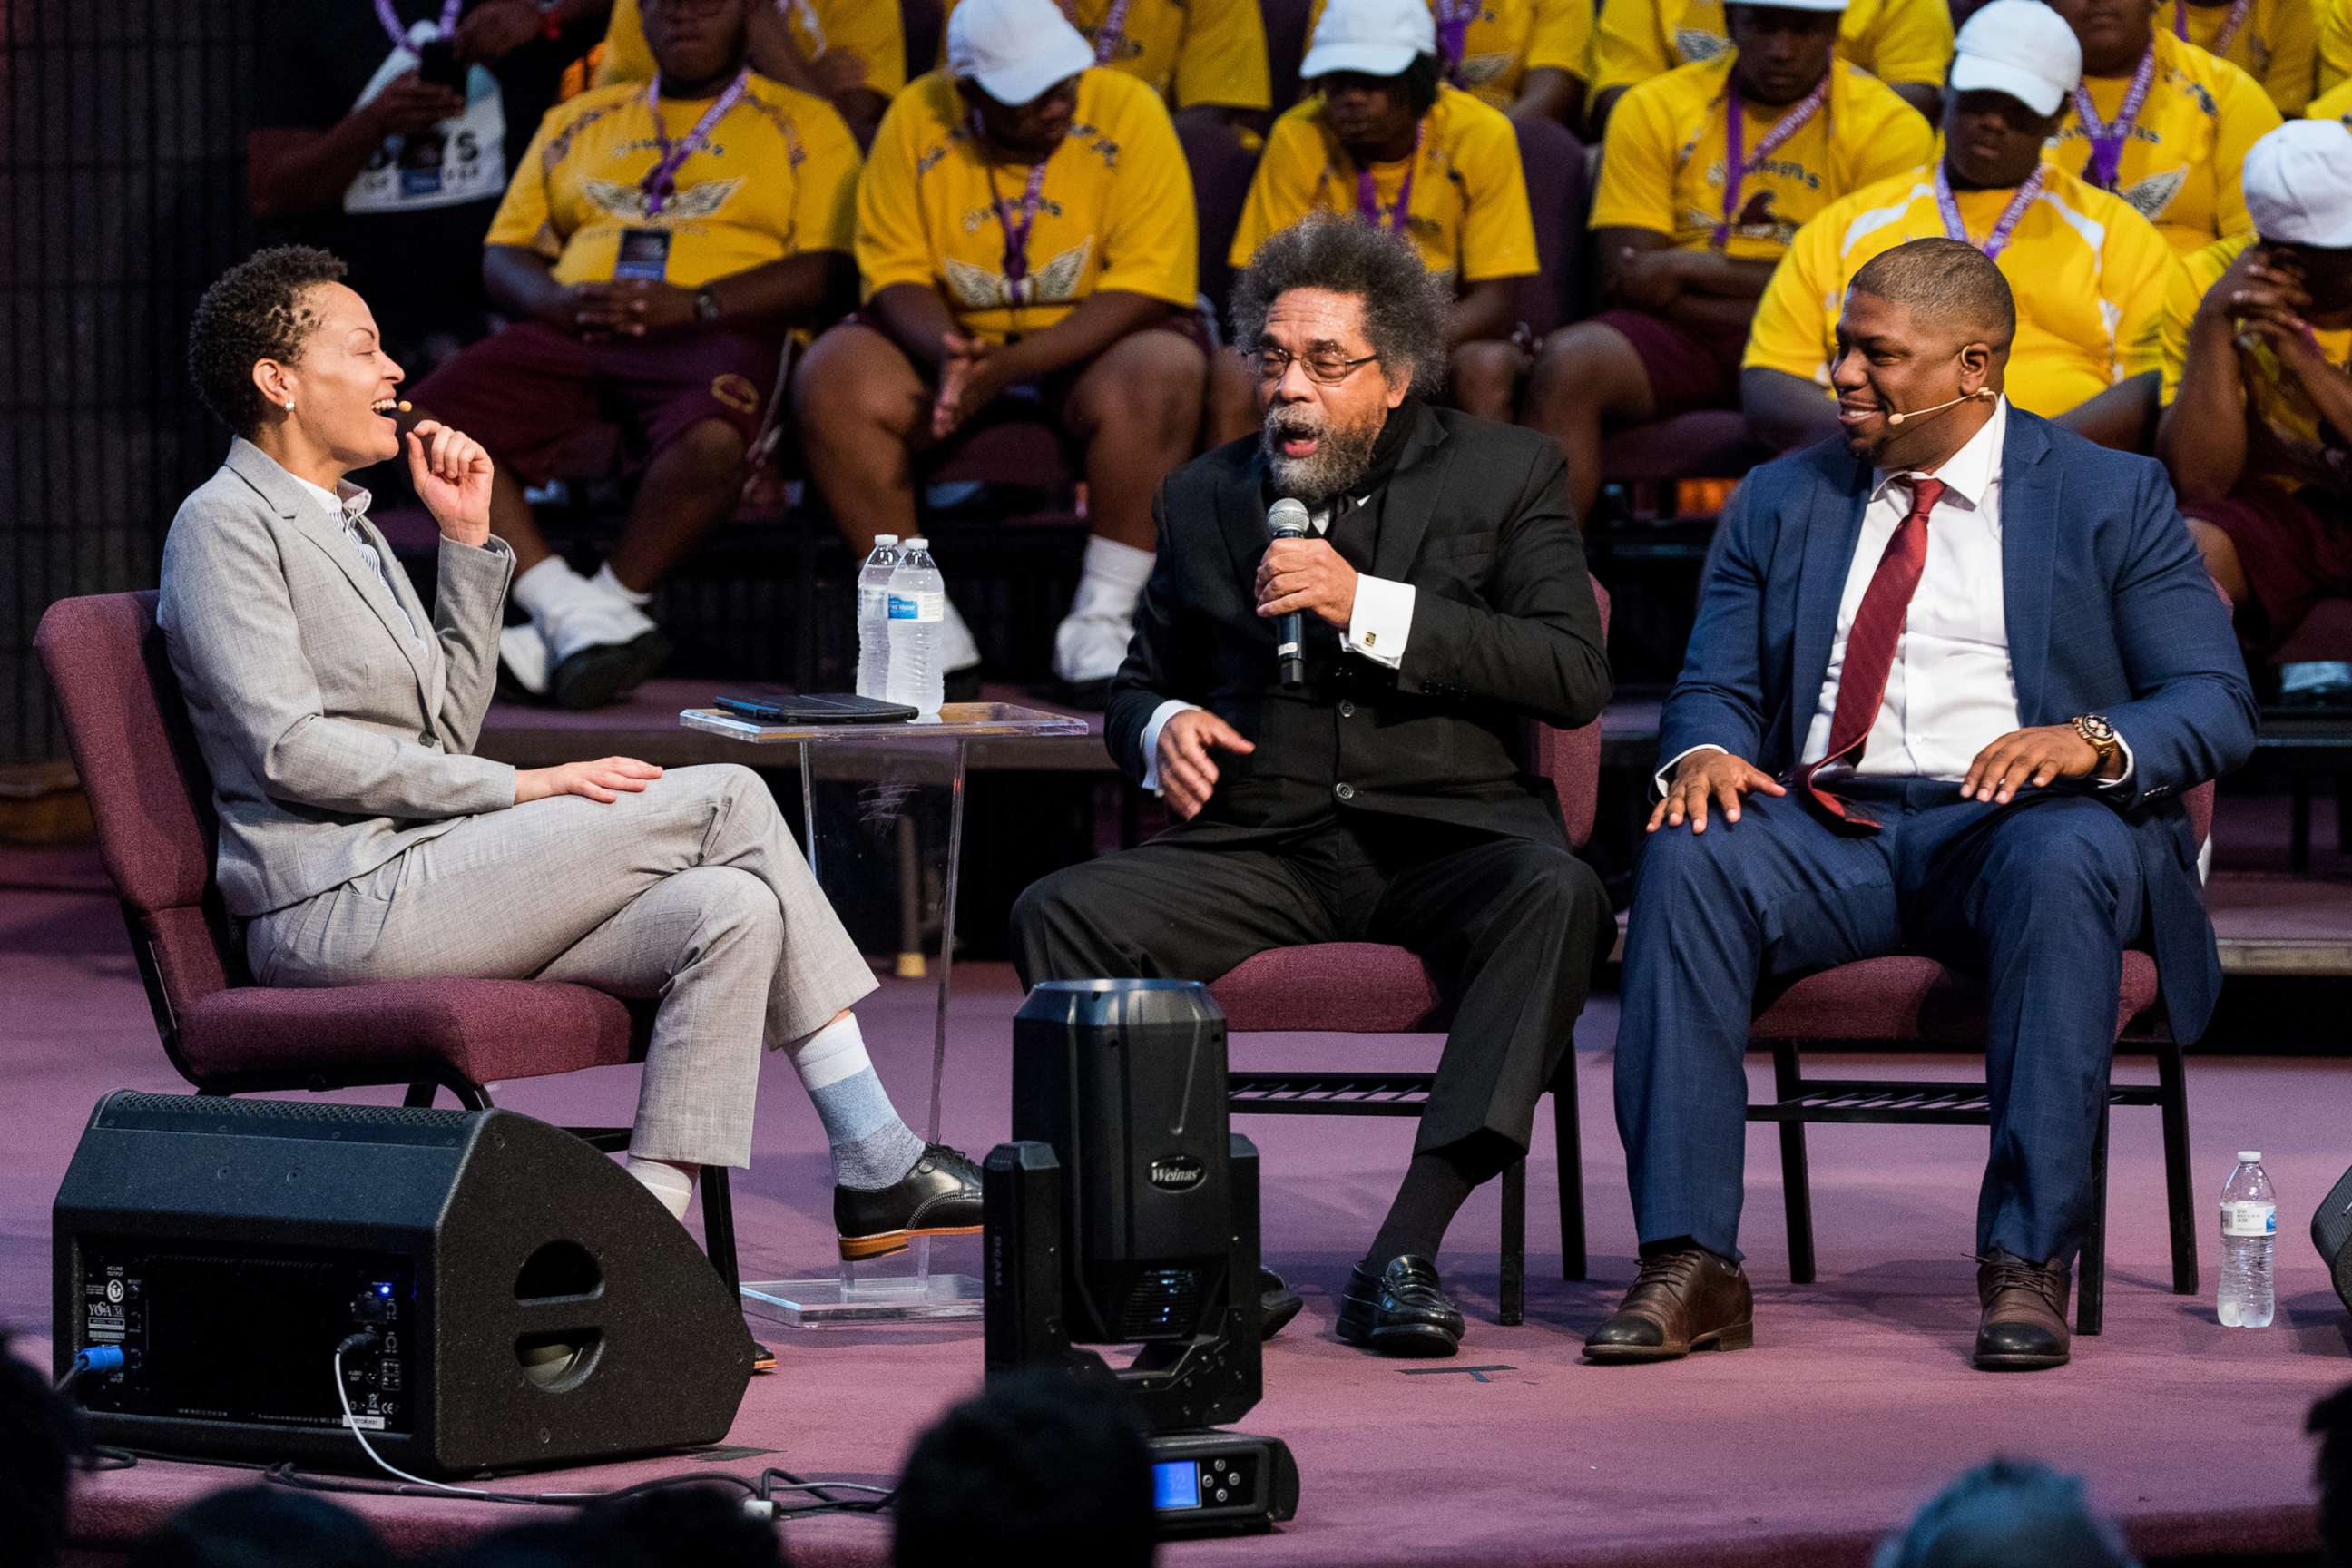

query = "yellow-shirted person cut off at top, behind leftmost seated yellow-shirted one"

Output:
[[593, 0, 906, 148]]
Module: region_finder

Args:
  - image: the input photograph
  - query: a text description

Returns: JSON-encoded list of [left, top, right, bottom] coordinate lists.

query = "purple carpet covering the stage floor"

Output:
[[0, 851, 2352, 1568]]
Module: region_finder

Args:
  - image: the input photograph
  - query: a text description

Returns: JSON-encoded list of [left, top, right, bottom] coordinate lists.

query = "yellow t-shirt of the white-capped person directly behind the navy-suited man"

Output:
[[1743, 164, 2178, 416]]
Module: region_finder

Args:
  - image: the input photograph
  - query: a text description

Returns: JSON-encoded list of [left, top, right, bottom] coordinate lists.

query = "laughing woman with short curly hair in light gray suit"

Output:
[[158, 247, 981, 1258]]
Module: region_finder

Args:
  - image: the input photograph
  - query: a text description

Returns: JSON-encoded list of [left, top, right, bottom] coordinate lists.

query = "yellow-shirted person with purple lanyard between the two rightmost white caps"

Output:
[[2043, 0, 2279, 254]]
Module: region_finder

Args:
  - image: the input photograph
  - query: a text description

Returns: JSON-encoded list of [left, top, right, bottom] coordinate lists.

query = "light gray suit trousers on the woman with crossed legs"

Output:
[[245, 767, 875, 1166]]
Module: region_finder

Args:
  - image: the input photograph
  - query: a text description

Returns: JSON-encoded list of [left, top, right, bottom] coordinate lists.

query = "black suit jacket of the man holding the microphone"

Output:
[[1105, 402, 1609, 844]]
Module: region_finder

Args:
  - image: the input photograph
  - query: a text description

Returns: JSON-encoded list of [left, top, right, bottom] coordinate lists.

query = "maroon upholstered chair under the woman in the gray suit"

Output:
[[33, 593, 736, 1289]]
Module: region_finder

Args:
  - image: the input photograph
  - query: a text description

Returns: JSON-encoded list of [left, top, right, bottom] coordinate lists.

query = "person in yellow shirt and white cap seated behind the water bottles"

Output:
[[793, 0, 1207, 689]]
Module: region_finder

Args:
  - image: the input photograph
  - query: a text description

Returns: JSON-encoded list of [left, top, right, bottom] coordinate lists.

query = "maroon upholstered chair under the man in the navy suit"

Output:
[[1748, 785, 2213, 1333]]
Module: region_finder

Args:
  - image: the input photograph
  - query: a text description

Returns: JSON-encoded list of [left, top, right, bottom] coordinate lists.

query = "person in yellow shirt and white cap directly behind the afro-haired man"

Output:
[[1216, 0, 1538, 430]]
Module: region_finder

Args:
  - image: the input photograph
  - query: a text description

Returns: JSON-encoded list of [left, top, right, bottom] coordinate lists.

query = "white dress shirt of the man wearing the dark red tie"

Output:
[[1656, 397, 2131, 795]]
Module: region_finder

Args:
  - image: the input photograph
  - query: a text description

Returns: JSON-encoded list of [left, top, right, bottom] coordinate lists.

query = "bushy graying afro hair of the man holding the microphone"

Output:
[[1232, 211, 1454, 397]]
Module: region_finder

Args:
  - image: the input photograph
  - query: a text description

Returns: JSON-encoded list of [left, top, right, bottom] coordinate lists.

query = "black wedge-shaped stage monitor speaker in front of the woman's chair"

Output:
[[54, 1091, 752, 1474]]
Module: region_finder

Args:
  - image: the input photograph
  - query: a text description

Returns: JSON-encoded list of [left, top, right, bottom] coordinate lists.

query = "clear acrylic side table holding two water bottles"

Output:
[[677, 703, 1087, 1328]]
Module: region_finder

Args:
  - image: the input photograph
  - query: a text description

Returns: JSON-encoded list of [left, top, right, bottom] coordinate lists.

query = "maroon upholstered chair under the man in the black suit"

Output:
[[1209, 583, 1609, 1324]]
